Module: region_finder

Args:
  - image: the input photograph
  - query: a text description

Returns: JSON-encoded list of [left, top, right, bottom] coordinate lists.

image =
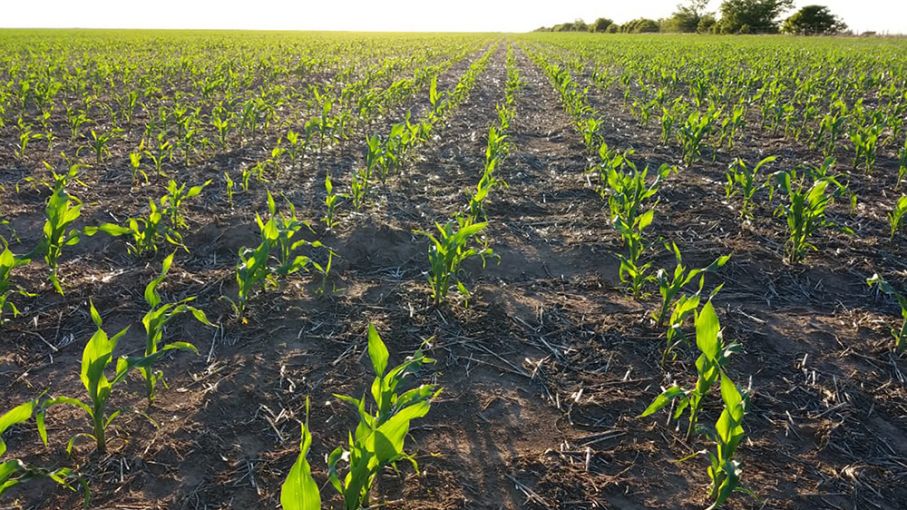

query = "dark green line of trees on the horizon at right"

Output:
[[536, 0, 847, 35]]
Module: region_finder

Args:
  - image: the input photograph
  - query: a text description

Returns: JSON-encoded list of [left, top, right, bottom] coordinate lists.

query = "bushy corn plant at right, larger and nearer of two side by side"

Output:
[[775, 170, 853, 264]]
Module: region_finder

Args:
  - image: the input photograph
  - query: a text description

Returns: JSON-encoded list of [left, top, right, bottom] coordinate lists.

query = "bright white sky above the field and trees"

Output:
[[0, 0, 907, 34]]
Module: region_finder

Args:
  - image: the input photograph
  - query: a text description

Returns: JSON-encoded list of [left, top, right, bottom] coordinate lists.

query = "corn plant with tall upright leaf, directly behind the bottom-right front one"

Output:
[[640, 301, 740, 440]]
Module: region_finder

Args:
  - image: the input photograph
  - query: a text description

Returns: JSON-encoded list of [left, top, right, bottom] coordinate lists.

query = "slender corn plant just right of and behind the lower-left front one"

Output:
[[138, 253, 214, 405]]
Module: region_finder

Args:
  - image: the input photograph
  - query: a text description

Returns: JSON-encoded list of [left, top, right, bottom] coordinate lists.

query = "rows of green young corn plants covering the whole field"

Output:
[[0, 31, 907, 510]]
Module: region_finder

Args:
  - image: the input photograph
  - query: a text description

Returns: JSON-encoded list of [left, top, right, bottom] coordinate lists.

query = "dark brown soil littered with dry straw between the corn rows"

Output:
[[0, 38, 907, 510]]
